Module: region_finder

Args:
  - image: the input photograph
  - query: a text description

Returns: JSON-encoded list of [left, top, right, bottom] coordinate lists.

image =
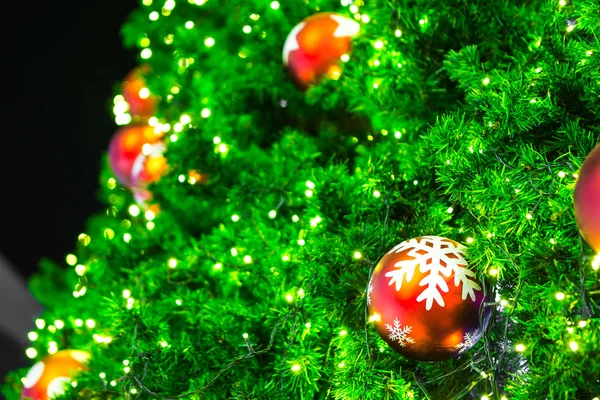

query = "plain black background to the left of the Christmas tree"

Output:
[[0, 0, 137, 278]]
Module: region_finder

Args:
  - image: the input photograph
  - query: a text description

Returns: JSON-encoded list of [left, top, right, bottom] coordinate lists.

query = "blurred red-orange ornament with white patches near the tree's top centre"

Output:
[[283, 12, 360, 88]]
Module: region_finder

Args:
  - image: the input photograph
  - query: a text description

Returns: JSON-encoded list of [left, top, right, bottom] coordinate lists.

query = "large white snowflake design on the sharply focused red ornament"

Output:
[[385, 236, 481, 310]]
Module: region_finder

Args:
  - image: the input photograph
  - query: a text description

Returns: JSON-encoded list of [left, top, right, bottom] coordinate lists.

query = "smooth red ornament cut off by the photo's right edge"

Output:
[[575, 145, 600, 253]]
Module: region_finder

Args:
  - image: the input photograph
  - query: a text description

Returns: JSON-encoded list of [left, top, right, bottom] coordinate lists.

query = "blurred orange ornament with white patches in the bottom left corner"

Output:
[[21, 350, 90, 400]]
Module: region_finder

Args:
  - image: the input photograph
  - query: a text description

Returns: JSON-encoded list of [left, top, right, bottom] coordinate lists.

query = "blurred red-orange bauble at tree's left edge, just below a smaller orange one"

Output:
[[108, 125, 166, 189]]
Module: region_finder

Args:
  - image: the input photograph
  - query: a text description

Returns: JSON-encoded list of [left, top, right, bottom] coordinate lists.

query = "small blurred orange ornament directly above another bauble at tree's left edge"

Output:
[[121, 64, 158, 117]]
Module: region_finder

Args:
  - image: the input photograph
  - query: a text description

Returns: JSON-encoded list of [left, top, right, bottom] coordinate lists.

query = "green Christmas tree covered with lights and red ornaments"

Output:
[[3, 0, 600, 400]]
